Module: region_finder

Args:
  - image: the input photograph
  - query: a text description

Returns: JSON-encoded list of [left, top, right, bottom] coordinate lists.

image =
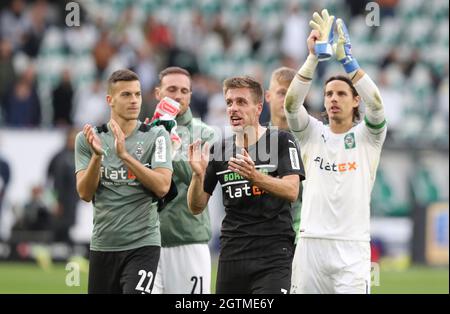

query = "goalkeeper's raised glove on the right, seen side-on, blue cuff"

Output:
[[333, 19, 359, 74]]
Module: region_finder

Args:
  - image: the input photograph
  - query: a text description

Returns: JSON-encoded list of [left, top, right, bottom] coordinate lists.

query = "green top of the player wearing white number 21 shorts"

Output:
[[159, 109, 214, 247]]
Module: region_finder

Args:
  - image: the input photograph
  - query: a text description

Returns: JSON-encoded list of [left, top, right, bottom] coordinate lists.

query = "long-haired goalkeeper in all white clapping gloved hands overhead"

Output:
[[285, 10, 386, 293]]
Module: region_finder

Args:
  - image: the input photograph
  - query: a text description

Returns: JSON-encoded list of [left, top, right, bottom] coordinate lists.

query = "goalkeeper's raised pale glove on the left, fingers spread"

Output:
[[309, 9, 334, 61]]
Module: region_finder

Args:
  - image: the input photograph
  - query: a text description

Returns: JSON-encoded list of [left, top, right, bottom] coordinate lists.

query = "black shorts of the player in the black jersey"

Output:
[[216, 252, 293, 294]]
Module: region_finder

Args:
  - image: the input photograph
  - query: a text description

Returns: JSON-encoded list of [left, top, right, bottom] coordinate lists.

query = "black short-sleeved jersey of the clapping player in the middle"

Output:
[[204, 129, 304, 260]]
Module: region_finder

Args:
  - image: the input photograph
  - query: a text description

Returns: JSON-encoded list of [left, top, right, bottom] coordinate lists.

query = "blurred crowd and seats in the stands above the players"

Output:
[[0, 0, 449, 146]]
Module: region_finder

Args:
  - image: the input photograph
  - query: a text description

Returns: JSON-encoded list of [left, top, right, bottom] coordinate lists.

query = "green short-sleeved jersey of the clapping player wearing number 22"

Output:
[[75, 121, 172, 251]]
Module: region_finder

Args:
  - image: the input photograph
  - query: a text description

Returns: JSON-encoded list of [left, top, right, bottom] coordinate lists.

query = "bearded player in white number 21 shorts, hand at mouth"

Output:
[[152, 67, 214, 294]]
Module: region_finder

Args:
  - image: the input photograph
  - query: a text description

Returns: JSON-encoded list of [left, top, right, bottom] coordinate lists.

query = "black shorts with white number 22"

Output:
[[88, 246, 161, 294]]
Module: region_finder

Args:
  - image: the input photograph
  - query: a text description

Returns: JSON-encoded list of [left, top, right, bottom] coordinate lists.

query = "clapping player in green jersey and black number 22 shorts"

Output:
[[75, 70, 172, 293]]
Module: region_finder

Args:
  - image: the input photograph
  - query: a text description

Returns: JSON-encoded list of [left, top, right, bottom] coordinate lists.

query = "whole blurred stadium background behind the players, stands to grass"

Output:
[[0, 0, 449, 293]]
